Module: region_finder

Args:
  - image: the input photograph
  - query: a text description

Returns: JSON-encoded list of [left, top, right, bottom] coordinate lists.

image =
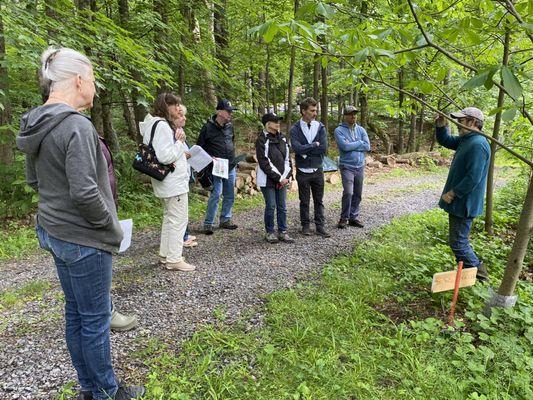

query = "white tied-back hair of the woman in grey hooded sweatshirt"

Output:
[[40, 47, 92, 92]]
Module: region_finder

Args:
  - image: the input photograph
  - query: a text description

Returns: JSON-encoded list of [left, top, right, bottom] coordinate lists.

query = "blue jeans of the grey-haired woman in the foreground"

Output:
[[37, 226, 118, 400]]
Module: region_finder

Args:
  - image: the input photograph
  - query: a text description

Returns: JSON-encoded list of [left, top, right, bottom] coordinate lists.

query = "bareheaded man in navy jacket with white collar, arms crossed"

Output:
[[290, 97, 331, 238]]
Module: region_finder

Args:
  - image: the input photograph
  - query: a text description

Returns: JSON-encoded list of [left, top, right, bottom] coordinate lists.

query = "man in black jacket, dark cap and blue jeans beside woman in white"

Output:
[[196, 99, 237, 235]]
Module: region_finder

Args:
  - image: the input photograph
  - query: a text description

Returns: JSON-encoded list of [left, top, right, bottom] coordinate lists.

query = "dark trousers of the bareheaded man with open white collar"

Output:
[[296, 168, 326, 227]]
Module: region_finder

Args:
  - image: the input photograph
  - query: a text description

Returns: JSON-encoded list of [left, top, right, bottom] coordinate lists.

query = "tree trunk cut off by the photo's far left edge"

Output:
[[0, 8, 13, 166]]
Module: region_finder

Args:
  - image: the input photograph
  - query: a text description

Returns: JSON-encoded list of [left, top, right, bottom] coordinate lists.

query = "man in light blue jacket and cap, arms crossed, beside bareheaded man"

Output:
[[335, 106, 370, 229]]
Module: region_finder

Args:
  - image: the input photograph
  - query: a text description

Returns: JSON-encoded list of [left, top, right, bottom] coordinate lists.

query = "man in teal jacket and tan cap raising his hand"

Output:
[[435, 107, 490, 281]]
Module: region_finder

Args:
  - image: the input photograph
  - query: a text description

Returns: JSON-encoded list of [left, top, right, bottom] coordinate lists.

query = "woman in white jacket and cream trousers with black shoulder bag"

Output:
[[139, 93, 196, 271]]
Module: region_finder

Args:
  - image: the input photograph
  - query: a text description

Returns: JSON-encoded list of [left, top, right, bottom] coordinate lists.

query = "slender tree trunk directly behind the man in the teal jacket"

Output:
[[485, 27, 511, 235]]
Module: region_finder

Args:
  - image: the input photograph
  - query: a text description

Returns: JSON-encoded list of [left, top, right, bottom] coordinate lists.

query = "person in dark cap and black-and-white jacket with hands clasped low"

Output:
[[255, 113, 294, 243]]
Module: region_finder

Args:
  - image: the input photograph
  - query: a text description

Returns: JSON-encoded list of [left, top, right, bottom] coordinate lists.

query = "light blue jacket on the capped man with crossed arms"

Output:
[[335, 123, 370, 168]]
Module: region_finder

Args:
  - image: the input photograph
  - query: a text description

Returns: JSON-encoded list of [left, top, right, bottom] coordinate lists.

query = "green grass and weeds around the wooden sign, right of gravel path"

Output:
[[138, 176, 533, 400]]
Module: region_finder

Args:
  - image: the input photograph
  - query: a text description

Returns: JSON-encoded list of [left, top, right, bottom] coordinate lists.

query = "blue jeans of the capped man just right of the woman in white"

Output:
[[204, 168, 237, 226]]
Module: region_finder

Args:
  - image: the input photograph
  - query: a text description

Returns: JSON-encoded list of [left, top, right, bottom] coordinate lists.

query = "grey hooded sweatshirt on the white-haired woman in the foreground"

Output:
[[17, 104, 122, 252]]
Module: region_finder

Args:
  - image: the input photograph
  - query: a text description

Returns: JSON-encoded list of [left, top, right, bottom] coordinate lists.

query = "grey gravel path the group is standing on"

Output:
[[0, 170, 445, 400]]
